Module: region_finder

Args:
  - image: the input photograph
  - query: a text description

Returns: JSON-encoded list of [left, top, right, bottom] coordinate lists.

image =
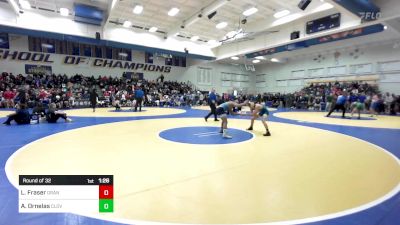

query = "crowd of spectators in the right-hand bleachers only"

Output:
[[253, 81, 400, 115]]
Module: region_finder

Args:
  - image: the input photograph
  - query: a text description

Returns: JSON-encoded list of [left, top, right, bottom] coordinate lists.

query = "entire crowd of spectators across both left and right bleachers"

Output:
[[0, 72, 400, 114]]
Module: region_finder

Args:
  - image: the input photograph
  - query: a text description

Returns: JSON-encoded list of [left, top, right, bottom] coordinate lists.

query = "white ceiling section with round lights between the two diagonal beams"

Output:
[[105, 0, 323, 41]]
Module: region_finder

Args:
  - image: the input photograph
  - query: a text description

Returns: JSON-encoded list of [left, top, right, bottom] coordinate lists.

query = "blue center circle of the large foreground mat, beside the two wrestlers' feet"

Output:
[[159, 126, 253, 145]]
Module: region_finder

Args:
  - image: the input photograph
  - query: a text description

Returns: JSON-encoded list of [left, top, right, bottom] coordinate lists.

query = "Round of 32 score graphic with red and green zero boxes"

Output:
[[18, 175, 114, 213]]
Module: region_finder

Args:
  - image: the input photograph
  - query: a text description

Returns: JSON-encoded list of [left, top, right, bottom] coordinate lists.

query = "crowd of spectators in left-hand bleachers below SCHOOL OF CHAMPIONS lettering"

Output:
[[0, 73, 200, 109]]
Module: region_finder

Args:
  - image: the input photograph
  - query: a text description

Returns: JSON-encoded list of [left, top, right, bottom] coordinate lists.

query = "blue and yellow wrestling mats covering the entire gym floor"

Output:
[[0, 107, 400, 225]]
